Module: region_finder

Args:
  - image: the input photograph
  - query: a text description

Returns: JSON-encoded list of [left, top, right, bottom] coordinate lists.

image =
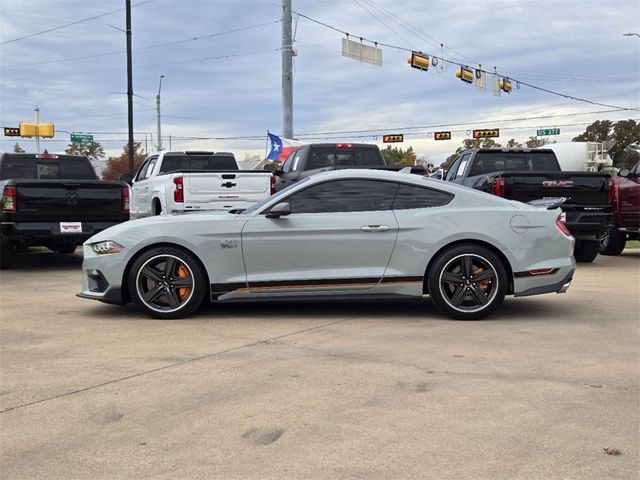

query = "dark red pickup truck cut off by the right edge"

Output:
[[600, 162, 640, 255]]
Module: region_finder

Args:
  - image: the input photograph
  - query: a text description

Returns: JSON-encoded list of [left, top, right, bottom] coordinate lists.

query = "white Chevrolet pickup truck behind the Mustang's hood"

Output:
[[130, 151, 273, 218]]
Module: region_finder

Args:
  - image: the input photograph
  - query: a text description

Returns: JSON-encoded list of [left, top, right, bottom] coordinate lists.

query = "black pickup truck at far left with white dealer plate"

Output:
[[0, 153, 129, 269]]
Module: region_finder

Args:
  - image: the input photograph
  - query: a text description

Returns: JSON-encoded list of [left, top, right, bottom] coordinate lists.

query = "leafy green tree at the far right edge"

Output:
[[573, 120, 640, 167]]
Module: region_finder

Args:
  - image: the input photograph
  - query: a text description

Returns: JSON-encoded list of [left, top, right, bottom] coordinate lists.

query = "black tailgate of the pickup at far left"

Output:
[[15, 180, 128, 222]]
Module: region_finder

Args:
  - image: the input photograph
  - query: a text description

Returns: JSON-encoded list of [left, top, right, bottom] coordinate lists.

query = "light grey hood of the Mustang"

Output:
[[85, 212, 249, 245]]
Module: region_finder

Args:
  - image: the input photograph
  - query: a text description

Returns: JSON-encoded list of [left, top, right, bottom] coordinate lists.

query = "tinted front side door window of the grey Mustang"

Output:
[[285, 180, 398, 214]]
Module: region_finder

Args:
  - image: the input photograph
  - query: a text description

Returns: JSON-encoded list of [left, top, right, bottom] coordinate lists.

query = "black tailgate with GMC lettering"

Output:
[[500, 172, 609, 206]]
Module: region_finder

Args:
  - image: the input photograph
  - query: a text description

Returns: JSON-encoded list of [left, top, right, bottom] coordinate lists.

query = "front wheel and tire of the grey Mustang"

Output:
[[128, 247, 208, 319]]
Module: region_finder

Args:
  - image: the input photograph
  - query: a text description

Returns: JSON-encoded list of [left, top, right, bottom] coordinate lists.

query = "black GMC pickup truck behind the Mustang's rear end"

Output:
[[444, 149, 613, 262]]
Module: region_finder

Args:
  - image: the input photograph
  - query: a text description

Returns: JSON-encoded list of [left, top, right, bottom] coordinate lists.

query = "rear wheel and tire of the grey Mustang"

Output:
[[427, 244, 509, 320]]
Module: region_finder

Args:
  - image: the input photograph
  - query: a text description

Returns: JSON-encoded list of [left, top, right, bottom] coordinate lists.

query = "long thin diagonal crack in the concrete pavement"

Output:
[[0, 319, 353, 414]]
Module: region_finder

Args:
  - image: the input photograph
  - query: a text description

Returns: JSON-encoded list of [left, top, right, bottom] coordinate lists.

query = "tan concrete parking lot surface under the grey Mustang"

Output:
[[0, 250, 640, 480]]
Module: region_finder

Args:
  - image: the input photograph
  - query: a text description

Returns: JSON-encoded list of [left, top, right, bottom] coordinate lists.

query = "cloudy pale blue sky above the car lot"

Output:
[[0, 0, 640, 169]]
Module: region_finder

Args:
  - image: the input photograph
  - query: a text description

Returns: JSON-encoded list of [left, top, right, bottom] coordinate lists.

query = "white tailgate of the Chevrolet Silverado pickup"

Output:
[[184, 170, 271, 204]]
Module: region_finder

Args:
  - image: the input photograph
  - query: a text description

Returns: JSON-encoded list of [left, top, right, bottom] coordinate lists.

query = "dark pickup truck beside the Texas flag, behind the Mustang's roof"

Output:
[[273, 143, 427, 191]]
